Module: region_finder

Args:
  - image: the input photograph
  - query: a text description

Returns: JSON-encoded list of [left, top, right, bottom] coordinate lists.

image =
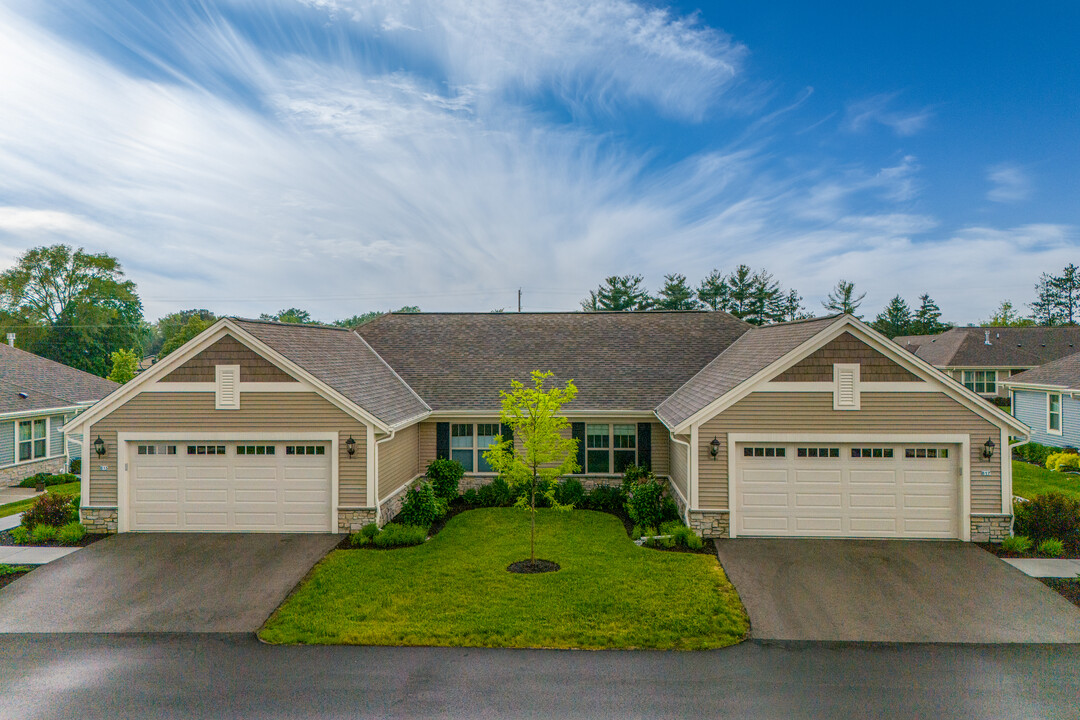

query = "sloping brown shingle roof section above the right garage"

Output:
[[657, 315, 842, 427]]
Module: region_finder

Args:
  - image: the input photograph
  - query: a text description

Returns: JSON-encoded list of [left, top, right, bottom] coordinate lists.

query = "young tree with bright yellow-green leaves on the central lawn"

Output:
[[484, 370, 579, 566]]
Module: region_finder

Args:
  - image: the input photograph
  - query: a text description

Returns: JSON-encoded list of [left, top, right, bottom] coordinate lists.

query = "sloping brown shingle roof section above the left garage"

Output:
[[233, 318, 429, 425]]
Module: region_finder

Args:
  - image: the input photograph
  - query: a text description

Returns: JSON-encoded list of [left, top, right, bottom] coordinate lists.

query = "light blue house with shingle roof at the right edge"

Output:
[[1003, 353, 1080, 448]]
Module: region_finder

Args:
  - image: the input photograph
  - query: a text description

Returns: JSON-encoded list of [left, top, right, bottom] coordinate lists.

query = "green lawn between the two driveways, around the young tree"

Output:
[[259, 508, 748, 650]]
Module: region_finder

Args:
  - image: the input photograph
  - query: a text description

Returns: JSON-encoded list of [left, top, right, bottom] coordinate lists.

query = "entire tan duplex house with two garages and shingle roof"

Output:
[[63, 312, 1027, 540]]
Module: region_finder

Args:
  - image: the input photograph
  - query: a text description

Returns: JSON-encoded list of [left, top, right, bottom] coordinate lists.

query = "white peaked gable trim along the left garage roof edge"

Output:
[[62, 317, 390, 432]]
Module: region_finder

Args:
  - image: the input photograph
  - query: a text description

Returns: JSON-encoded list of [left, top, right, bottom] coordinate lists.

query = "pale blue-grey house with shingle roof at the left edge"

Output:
[[0, 344, 119, 487]]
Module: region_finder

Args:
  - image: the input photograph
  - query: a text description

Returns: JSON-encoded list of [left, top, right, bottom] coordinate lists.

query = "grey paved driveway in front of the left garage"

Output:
[[0, 533, 341, 633]]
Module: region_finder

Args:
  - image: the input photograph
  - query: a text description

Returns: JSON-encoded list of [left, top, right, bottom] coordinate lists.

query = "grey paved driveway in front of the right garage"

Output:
[[716, 539, 1080, 642]]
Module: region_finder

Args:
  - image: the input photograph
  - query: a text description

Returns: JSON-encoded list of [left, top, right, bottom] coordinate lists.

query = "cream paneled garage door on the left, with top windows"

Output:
[[127, 440, 332, 532]]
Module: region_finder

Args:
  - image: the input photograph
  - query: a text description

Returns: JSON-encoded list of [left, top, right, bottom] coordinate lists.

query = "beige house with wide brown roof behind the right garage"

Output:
[[893, 327, 1080, 397]]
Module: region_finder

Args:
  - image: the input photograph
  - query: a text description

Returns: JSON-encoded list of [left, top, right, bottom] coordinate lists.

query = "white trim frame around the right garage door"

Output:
[[728, 433, 976, 542]]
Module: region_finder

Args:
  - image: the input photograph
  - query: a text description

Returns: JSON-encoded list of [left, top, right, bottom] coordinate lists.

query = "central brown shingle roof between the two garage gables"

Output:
[[356, 312, 751, 412]]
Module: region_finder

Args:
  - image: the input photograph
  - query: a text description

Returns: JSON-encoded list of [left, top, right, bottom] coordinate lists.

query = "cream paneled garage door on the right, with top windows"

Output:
[[734, 443, 961, 538]]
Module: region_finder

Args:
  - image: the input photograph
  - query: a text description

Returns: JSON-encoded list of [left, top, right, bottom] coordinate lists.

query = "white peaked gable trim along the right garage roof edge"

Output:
[[674, 315, 1031, 436]]
